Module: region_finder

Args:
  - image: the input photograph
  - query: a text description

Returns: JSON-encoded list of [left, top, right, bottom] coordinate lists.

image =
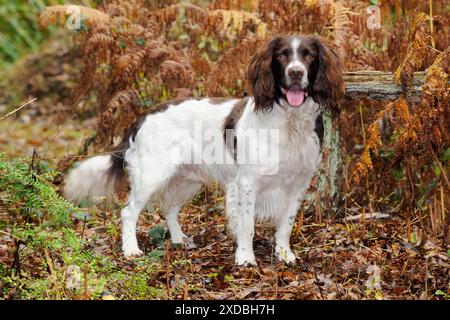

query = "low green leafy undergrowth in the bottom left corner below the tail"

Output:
[[0, 154, 165, 299]]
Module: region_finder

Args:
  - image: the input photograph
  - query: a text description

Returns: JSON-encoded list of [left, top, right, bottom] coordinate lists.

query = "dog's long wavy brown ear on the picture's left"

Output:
[[247, 37, 280, 111]]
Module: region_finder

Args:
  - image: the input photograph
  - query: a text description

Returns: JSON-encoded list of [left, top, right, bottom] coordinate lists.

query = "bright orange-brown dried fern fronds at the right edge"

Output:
[[352, 49, 450, 183]]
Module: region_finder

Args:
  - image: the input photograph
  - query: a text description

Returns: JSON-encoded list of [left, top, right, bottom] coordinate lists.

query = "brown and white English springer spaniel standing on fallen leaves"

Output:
[[64, 36, 344, 265]]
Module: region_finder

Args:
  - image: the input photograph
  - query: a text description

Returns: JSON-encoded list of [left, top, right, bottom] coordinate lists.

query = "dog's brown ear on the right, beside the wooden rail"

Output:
[[313, 38, 344, 109]]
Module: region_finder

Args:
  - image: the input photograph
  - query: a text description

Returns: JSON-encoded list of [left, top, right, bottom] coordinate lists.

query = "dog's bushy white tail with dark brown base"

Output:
[[64, 153, 125, 203]]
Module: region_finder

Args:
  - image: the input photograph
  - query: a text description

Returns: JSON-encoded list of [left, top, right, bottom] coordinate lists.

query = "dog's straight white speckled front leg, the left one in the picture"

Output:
[[234, 177, 256, 265]]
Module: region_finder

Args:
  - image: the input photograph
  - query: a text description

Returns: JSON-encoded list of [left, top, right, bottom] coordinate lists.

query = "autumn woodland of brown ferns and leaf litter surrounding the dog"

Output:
[[0, 0, 450, 299]]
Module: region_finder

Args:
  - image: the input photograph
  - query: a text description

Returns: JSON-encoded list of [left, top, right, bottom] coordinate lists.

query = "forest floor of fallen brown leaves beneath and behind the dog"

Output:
[[0, 112, 450, 299]]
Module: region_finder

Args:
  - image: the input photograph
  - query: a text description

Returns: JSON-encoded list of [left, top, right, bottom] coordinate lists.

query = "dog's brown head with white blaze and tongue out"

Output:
[[247, 36, 344, 111]]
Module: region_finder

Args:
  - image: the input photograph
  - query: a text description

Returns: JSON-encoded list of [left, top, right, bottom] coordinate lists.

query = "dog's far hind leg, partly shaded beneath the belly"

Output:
[[160, 180, 202, 249]]
